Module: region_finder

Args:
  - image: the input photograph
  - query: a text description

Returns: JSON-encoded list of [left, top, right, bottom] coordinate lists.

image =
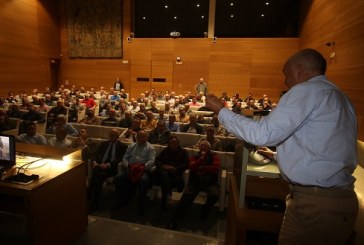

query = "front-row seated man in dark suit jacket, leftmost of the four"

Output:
[[87, 129, 127, 212]]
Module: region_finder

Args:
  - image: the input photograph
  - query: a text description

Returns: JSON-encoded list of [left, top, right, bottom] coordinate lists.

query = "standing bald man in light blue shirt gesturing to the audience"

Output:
[[207, 49, 358, 244]]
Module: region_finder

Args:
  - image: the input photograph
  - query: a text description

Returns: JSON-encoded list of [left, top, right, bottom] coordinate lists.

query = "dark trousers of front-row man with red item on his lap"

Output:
[[114, 172, 149, 210]]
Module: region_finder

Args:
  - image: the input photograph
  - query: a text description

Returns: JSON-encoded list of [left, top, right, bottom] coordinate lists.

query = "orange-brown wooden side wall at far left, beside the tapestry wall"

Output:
[[0, 0, 60, 96]]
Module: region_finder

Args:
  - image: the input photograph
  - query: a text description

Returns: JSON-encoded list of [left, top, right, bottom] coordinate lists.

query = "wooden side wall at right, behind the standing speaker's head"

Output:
[[300, 0, 364, 140]]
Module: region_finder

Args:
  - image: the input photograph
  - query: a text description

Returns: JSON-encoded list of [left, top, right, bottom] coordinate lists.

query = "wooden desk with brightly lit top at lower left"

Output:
[[0, 145, 88, 244]]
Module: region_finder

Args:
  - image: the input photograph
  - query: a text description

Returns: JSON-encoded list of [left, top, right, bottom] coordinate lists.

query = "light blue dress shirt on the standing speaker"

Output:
[[219, 75, 357, 189]]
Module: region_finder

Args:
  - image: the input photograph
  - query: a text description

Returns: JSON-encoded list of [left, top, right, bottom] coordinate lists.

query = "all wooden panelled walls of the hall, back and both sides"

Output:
[[0, 0, 364, 139]]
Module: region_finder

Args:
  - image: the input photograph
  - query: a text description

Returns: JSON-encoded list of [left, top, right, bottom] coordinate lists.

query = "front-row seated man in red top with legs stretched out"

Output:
[[167, 140, 220, 230]]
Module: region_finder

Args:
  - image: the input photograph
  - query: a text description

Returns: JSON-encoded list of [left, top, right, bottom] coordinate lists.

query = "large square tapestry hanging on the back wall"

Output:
[[66, 0, 122, 58]]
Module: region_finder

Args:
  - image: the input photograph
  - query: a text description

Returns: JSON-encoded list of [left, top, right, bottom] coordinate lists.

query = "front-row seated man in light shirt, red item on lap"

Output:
[[113, 130, 156, 215]]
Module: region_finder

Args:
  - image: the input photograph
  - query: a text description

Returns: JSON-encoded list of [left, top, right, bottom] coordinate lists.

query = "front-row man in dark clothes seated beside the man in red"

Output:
[[153, 136, 189, 210]]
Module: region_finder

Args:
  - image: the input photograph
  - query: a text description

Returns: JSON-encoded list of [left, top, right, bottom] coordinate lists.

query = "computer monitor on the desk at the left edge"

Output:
[[0, 134, 16, 169]]
